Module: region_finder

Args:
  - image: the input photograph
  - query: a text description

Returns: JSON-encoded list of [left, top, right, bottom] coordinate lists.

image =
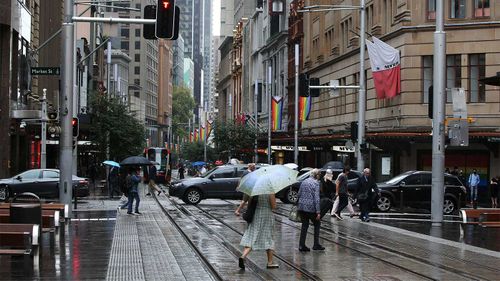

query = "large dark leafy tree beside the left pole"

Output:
[[89, 93, 146, 162]]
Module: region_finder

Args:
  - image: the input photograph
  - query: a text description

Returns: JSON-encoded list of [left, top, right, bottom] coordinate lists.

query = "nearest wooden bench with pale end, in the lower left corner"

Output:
[[0, 223, 40, 264]]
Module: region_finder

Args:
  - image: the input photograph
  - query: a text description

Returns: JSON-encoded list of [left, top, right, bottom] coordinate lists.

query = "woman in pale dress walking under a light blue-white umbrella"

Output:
[[237, 165, 297, 269]]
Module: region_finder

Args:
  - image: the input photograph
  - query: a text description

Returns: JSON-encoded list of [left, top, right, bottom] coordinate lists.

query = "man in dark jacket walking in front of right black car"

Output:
[[357, 168, 380, 222]]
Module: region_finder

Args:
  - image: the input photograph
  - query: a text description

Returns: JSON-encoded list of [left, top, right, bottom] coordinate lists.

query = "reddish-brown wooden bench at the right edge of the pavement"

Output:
[[460, 208, 500, 236]]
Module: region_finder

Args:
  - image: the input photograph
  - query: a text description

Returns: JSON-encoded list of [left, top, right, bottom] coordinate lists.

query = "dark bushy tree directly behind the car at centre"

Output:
[[213, 120, 256, 160]]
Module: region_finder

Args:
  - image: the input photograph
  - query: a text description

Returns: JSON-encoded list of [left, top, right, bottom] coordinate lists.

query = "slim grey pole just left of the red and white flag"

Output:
[[356, 0, 366, 171]]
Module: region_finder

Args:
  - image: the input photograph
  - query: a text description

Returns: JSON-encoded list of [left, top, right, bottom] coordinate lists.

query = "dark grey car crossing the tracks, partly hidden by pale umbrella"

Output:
[[169, 164, 254, 205]]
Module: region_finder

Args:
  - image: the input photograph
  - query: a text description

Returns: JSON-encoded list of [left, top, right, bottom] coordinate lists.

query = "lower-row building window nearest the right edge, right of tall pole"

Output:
[[469, 54, 486, 102]]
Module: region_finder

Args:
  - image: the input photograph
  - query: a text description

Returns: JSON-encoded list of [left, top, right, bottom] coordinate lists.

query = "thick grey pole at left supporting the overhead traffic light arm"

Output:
[[59, 0, 75, 212]]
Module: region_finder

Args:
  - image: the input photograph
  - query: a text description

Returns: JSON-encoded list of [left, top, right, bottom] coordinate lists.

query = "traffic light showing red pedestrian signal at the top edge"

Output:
[[156, 0, 178, 39]]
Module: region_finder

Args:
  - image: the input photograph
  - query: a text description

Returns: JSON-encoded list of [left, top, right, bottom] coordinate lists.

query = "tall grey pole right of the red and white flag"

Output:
[[431, 0, 446, 226]]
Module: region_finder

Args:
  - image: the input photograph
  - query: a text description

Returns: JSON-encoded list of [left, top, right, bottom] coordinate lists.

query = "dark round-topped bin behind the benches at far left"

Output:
[[10, 192, 42, 226]]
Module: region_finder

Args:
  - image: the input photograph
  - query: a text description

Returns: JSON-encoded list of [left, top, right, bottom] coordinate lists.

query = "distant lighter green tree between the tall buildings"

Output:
[[172, 87, 196, 138]]
